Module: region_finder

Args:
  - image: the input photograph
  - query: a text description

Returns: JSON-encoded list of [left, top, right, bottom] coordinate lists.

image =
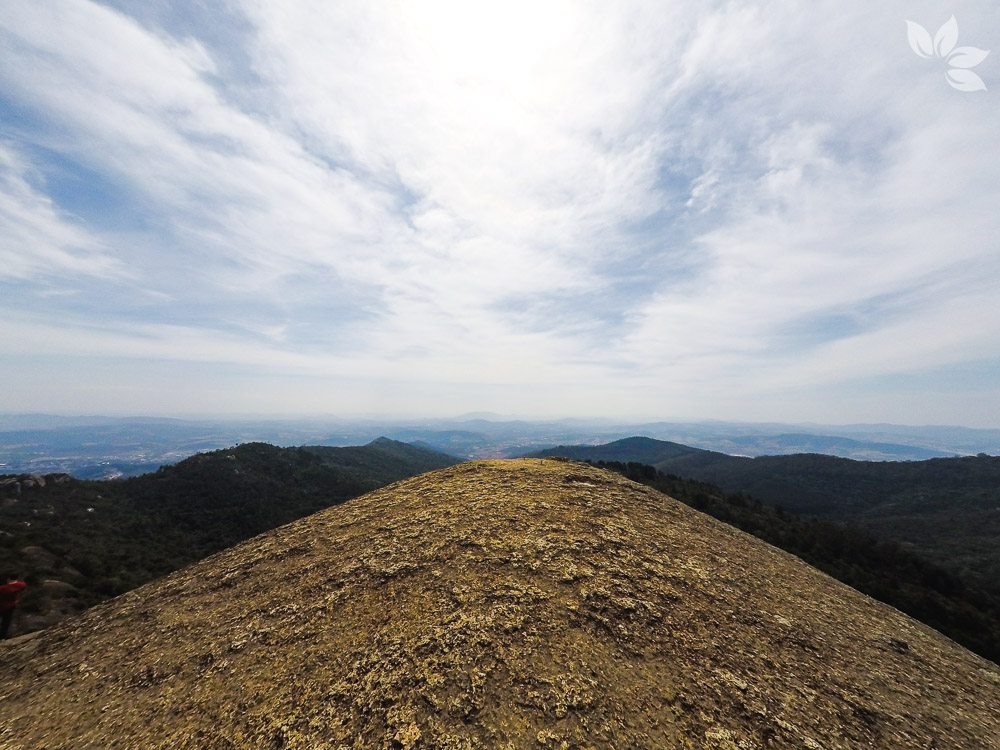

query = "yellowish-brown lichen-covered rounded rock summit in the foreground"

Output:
[[0, 460, 1000, 750]]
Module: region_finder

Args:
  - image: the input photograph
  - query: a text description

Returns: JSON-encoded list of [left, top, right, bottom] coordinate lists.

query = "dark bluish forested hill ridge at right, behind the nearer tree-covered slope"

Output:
[[530, 437, 1000, 580]]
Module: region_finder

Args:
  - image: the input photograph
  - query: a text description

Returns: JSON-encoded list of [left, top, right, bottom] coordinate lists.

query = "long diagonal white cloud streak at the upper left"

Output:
[[3, 2, 402, 288]]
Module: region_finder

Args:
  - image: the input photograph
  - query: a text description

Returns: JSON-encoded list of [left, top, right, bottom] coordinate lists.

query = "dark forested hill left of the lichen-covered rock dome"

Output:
[[0, 438, 459, 632]]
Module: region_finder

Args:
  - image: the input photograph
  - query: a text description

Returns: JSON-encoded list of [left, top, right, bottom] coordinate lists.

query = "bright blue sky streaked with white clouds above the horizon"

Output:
[[0, 0, 1000, 427]]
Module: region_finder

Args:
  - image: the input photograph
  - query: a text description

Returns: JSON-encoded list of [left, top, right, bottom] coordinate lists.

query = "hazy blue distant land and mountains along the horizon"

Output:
[[0, 414, 1000, 479]]
